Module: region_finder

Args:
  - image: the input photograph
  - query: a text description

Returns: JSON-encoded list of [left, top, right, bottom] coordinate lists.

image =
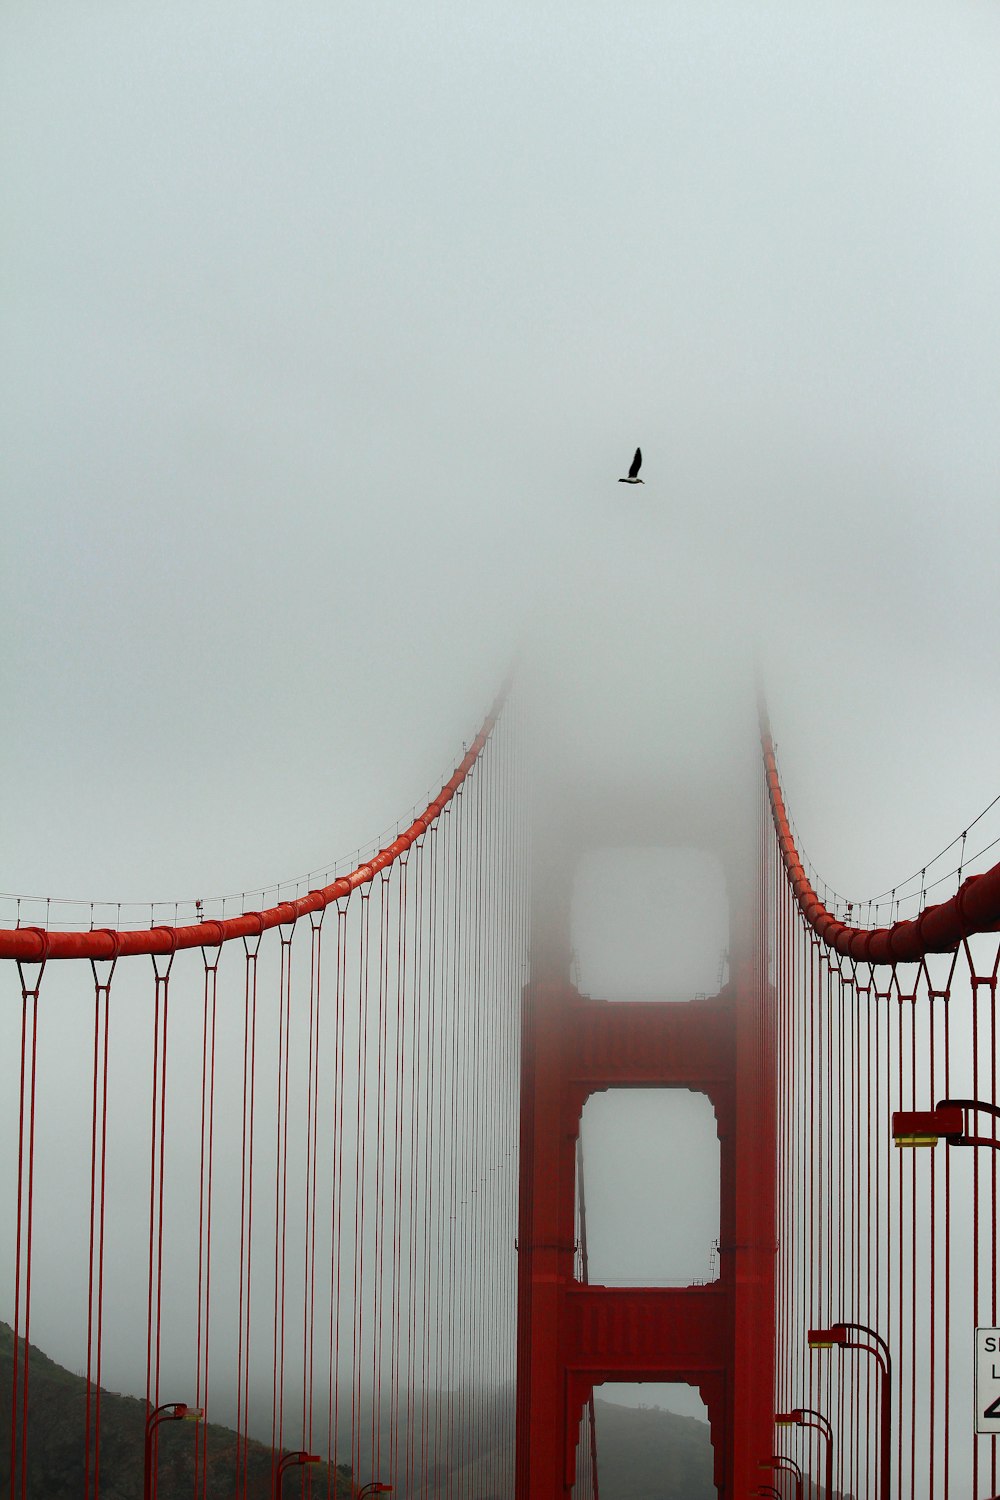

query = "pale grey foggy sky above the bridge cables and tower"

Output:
[[0, 0, 1000, 1440]]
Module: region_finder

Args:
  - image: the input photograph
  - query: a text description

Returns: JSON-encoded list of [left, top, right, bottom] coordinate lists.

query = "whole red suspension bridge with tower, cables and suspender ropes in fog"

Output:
[[0, 687, 1000, 1500]]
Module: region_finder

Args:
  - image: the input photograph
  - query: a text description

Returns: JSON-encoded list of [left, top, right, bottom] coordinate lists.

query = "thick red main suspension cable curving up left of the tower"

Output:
[[0, 683, 508, 963]]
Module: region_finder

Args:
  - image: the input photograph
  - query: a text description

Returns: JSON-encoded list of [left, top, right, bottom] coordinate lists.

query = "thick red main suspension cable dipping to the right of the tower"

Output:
[[760, 714, 1000, 963]]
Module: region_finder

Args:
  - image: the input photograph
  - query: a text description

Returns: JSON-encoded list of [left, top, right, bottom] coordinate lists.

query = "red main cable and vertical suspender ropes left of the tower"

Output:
[[0, 710, 528, 1500]]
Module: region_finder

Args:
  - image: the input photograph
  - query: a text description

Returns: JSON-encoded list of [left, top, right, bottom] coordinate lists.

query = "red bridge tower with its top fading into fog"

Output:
[[516, 780, 775, 1500]]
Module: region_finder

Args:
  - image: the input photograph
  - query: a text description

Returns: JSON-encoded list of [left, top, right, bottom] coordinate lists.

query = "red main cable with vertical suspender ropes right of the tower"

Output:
[[762, 714, 1000, 1500]]
